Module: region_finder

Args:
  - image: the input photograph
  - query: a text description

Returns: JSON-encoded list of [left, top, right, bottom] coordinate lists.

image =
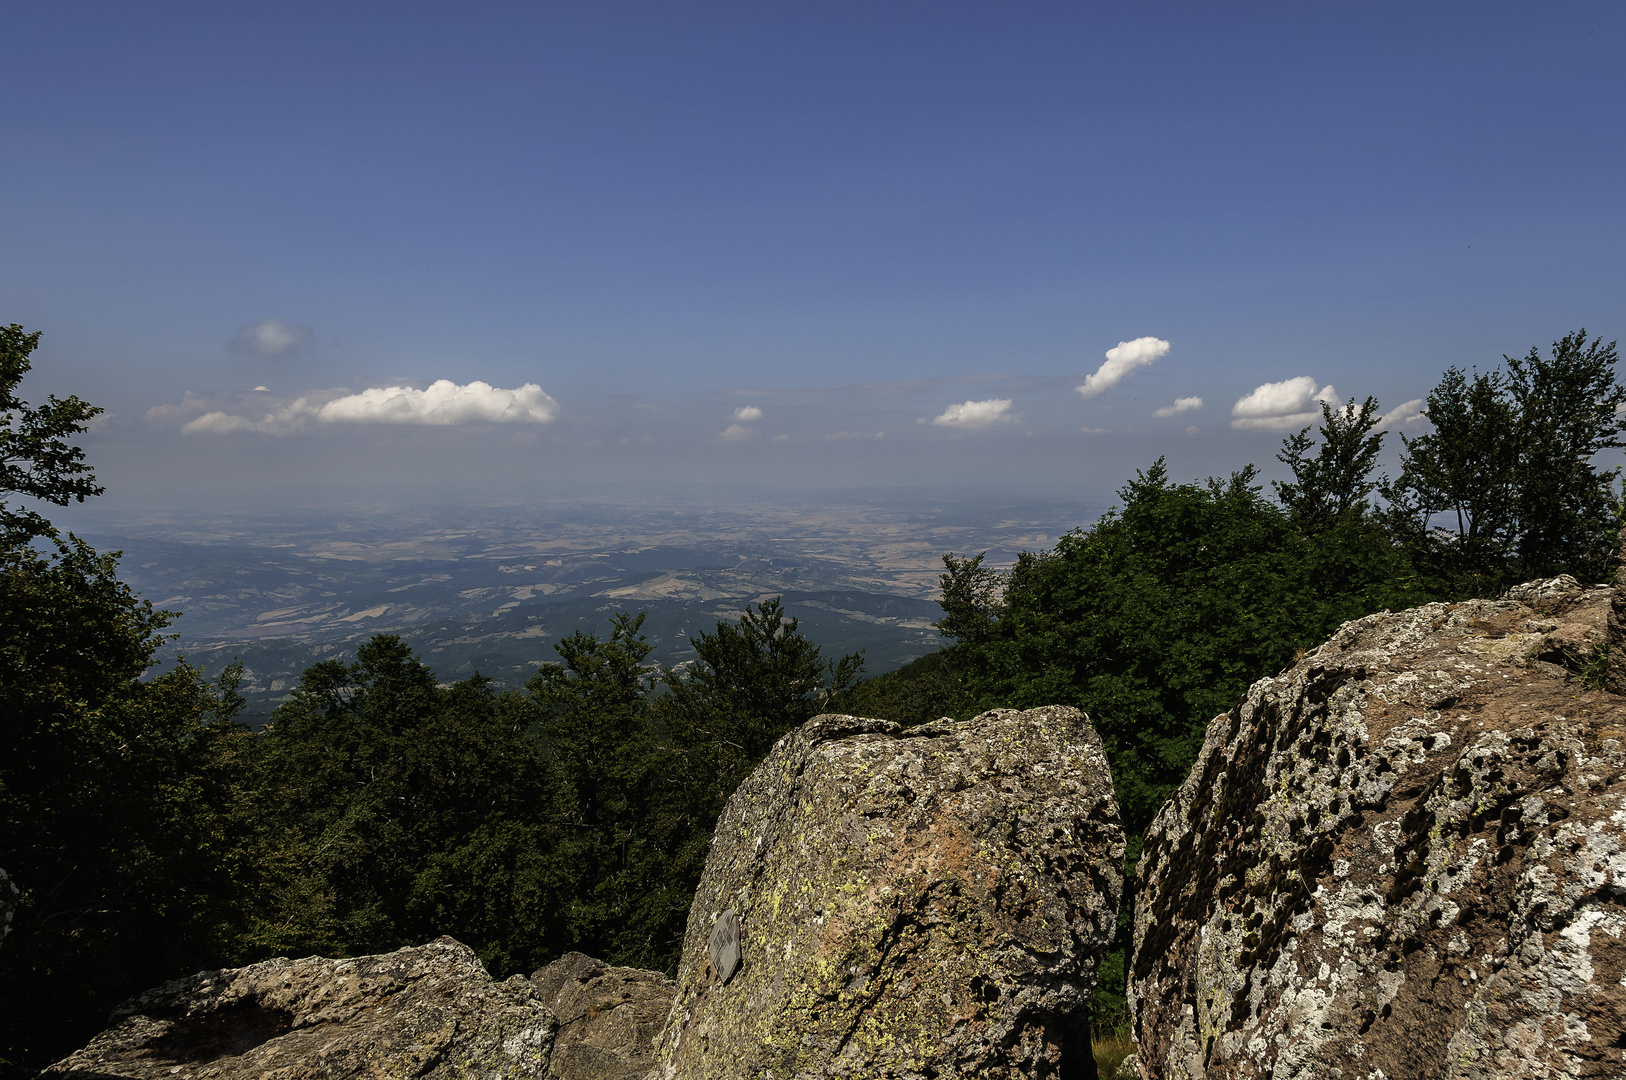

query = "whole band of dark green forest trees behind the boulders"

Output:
[[0, 325, 1626, 1077]]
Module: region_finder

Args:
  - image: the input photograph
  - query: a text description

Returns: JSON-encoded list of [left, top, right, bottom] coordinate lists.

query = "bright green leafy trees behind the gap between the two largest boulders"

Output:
[[945, 459, 1413, 830]]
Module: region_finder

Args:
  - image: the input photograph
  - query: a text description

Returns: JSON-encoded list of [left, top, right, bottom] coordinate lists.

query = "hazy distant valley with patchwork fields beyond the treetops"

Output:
[[88, 499, 1086, 721]]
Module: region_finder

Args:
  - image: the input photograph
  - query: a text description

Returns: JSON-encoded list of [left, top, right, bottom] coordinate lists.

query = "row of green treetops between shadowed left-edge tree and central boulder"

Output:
[[234, 600, 860, 973]]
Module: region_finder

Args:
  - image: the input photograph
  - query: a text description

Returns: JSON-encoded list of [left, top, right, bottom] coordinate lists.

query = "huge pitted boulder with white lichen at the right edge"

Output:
[[1130, 579, 1626, 1080]]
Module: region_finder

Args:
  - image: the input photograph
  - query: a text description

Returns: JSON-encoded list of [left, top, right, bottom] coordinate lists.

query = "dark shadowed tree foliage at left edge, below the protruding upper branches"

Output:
[[0, 538, 242, 1069]]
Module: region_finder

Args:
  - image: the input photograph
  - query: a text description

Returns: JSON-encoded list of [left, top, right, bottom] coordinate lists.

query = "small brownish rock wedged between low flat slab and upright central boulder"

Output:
[[530, 953, 676, 1080]]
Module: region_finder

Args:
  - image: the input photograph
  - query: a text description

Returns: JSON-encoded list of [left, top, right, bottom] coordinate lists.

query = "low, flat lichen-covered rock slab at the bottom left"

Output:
[[41, 937, 558, 1080]]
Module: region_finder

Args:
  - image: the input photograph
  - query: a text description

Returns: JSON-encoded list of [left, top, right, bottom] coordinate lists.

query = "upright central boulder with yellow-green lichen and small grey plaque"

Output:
[[652, 708, 1124, 1080]]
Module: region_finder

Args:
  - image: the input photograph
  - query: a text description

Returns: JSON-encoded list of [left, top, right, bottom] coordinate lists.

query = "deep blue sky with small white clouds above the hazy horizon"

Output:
[[0, 2, 1626, 506]]
